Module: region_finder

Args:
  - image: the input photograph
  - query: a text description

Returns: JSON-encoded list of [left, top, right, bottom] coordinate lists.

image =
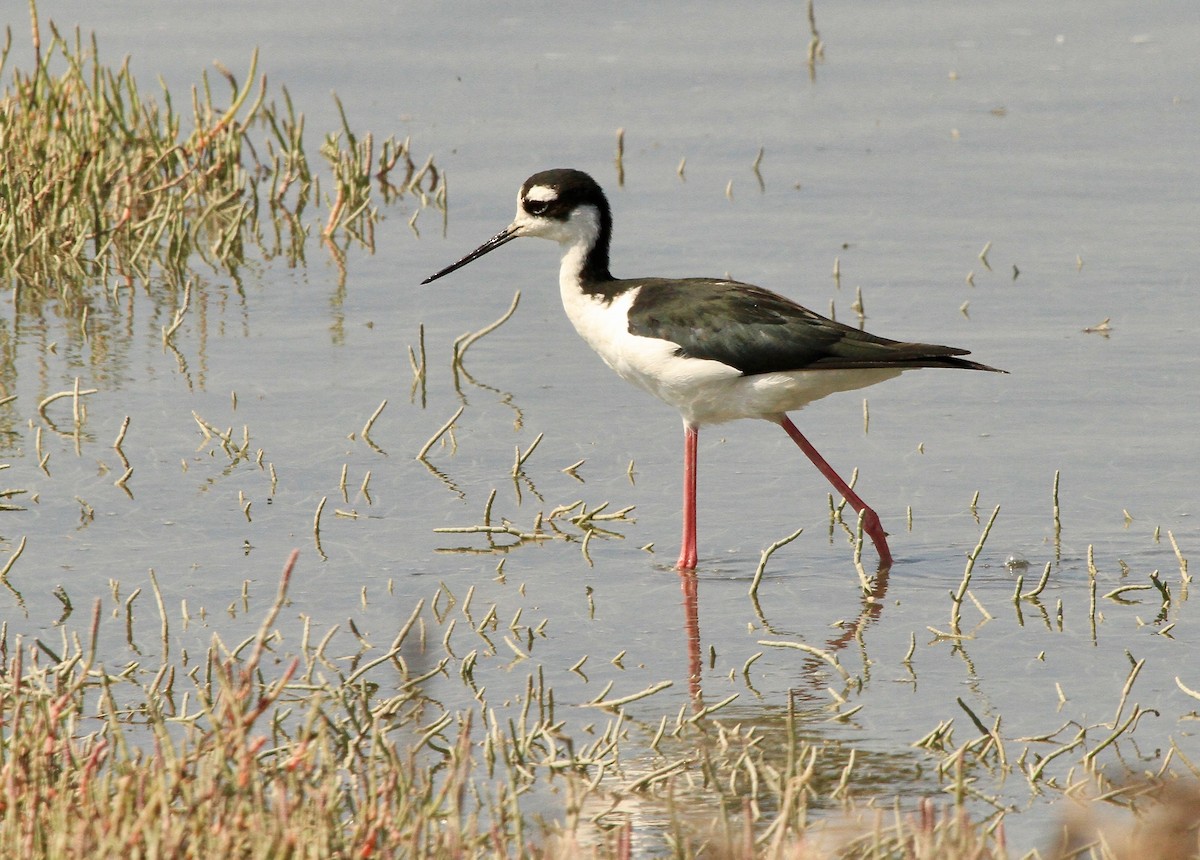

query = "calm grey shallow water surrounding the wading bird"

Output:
[[0, 2, 1200, 852]]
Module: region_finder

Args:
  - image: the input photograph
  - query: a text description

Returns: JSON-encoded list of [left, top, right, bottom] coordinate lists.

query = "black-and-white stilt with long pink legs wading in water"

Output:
[[421, 169, 1003, 570]]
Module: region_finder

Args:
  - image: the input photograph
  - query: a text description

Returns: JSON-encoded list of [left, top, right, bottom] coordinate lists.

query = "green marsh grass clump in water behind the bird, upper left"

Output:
[[0, 2, 445, 303]]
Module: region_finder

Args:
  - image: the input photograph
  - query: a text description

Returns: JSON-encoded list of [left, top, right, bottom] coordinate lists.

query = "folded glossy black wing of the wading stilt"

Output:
[[629, 278, 996, 375]]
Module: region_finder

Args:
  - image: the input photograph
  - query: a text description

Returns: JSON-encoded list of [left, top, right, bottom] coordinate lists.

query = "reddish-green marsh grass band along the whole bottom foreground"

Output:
[[0, 537, 1200, 860]]
